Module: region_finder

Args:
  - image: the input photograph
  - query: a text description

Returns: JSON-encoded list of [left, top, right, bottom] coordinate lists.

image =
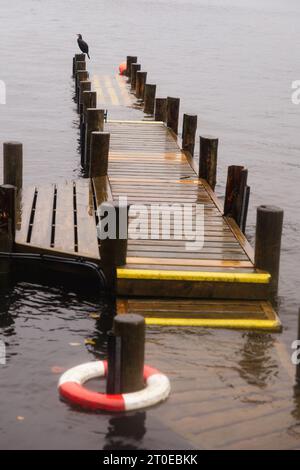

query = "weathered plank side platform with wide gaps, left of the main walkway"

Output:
[[16, 177, 111, 260]]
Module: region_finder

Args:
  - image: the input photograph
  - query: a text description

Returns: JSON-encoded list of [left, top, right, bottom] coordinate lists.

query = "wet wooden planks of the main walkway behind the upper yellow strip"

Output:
[[106, 121, 253, 276]]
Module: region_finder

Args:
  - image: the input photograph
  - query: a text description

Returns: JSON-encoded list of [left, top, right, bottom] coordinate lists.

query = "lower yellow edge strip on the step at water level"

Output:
[[145, 317, 281, 332]]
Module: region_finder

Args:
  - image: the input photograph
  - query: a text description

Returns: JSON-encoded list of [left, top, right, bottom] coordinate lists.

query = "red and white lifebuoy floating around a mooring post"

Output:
[[58, 361, 171, 411]]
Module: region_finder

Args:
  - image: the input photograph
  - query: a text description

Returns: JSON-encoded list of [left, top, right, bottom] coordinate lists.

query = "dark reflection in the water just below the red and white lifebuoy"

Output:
[[103, 411, 146, 450]]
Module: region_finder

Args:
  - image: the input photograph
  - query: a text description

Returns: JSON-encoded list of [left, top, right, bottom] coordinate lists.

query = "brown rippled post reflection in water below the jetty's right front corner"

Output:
[[239, 332, 278, 387]]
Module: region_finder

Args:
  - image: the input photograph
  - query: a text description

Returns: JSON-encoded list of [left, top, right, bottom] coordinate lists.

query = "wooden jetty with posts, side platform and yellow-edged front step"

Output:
[[0, 54, 280, 331]]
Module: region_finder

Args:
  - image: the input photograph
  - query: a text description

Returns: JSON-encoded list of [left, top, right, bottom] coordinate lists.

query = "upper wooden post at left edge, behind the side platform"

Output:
[[3, 142, 23, 191]]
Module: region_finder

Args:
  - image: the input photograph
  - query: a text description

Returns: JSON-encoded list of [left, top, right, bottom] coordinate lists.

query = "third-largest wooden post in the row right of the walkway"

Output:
[[199, 136, 219, 190]]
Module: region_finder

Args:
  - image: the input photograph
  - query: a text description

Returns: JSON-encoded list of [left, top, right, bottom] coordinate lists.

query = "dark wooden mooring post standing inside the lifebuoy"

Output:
[[107, 314, 145, 393]]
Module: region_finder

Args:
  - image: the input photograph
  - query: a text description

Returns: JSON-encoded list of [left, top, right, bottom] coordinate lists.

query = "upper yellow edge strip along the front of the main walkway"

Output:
[[117, 268, 271, 284]]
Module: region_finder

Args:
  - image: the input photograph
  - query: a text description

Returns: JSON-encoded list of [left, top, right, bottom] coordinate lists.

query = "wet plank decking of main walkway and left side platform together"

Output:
[[12, 117, 278, 328]]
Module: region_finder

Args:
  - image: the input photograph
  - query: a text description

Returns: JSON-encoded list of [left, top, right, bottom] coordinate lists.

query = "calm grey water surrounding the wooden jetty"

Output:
[[0, 0, 300, 448]]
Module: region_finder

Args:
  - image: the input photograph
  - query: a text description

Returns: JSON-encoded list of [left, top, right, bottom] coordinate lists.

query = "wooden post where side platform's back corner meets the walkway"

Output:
[[89, 132, 110, 178]]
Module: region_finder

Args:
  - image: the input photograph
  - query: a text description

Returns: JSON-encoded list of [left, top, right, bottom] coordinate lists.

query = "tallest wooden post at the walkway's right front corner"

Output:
[[255, 206, 284, 296]]
